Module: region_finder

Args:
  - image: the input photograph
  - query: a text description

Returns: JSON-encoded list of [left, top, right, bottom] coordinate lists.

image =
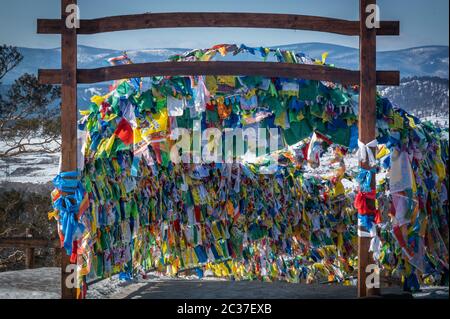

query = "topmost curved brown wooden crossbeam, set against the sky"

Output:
[[37, 12, 400, 36]]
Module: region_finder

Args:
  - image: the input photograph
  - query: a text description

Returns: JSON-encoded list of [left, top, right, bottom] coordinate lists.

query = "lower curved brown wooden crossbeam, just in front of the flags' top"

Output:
[[39, 61, 400, 85]]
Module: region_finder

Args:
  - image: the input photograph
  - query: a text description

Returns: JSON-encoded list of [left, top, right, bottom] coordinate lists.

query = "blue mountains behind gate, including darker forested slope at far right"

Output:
[[0, 43, 449, 115]]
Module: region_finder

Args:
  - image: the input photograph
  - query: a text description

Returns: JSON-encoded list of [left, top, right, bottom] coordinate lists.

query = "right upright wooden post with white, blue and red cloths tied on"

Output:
[[358, 0, 379, 298]]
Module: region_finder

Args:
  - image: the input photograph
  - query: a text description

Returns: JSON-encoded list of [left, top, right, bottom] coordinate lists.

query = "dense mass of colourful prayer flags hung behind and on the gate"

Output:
[[50, 45, 449, 298]]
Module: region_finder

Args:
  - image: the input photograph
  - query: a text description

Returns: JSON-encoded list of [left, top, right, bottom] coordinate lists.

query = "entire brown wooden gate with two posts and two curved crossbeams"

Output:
[[37, 0, 400, 299]]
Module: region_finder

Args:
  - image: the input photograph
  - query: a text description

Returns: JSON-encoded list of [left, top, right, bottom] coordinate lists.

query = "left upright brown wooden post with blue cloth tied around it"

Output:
[[61, 0, 77, 299]]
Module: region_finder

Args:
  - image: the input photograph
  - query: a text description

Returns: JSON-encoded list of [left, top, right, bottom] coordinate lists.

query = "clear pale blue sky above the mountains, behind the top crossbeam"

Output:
[[0, 0, 449, 50]]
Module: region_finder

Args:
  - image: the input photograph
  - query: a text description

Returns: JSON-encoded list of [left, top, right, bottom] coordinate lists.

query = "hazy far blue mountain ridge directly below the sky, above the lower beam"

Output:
[[3, 43, 449, 84]]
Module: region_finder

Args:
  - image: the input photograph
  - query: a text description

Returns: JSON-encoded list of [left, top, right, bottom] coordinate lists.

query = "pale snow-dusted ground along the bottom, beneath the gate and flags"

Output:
[[0, 268, 449, 299]]
